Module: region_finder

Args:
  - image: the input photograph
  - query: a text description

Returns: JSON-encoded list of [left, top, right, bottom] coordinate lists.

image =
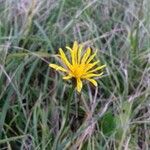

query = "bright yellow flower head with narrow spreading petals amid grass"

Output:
[[49, 41, 106, 92]]
